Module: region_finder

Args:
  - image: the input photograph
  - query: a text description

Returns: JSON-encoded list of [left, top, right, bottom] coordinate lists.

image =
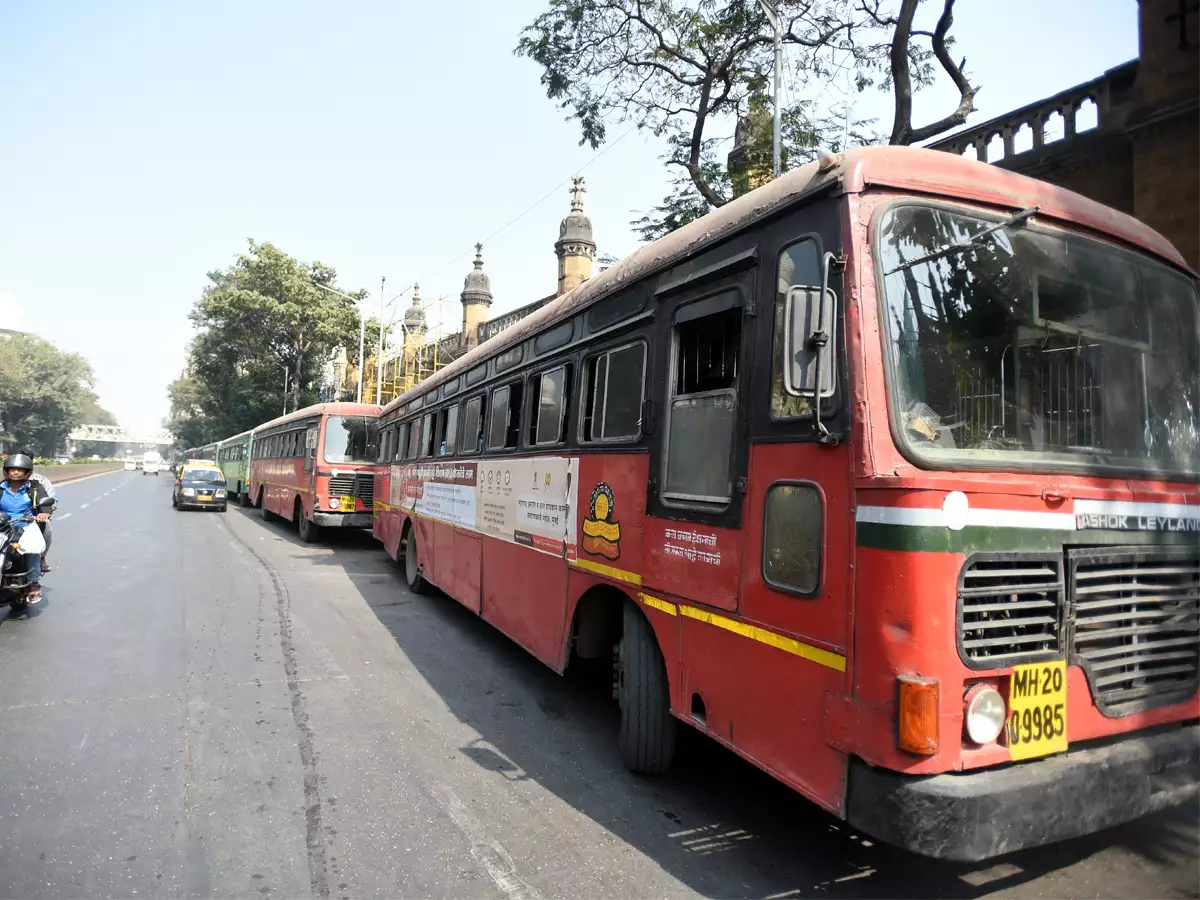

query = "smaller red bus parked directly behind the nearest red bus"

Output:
[[247, 403, 379, 541]]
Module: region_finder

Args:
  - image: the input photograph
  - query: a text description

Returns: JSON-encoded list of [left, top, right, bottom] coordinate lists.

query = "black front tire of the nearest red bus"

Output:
[[617, 604, 676, 775]]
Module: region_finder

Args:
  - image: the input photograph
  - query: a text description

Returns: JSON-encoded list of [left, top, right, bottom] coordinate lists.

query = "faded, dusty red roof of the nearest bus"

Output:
[[379, 146, 1194, 427]]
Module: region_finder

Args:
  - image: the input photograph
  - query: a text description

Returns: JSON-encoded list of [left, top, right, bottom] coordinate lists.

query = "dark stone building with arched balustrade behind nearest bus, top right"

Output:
[[930, 0, 1200, 269]]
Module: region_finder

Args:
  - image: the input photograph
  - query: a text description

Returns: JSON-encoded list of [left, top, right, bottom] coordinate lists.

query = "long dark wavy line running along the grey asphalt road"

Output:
[[222, 520, 329, 898]]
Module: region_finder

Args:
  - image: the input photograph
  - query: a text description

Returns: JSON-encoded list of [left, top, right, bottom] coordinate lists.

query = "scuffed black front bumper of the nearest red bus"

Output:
[[846, 725, 1200, 862]]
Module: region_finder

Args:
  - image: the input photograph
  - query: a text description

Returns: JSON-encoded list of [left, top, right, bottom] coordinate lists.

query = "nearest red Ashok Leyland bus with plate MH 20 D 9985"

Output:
[[374, 148, 1200, 860]]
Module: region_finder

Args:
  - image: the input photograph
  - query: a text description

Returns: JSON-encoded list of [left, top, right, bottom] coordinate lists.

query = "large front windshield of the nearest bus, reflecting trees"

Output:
[[877, 204, 1200, 473]]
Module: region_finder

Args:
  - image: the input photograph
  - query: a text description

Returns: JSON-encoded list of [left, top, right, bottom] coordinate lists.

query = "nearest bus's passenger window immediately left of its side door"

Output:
[[581, 341, 646, 443]]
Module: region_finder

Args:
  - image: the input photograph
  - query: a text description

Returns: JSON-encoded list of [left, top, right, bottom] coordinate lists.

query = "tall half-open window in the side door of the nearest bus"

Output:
[[662, 296, 742, 505]]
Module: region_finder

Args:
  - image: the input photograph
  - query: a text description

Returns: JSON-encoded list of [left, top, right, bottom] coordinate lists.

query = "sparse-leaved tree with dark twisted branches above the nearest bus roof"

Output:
[[516, 0, 976, 239]]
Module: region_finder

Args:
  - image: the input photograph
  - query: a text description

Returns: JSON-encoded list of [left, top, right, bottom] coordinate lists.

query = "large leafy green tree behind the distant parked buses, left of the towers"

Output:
[[168, 240, 365, 448]]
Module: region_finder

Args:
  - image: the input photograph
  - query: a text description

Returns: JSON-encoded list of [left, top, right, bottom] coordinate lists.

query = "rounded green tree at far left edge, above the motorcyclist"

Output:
[[0, 335, 96, 456]]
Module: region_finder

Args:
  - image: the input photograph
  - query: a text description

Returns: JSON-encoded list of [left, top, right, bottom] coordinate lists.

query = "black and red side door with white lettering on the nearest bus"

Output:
[[642, 256, 756, 611]]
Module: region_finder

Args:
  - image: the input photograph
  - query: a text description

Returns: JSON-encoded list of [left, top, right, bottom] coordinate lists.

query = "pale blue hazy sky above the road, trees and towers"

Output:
[[0, 0, 1138, 428]]
